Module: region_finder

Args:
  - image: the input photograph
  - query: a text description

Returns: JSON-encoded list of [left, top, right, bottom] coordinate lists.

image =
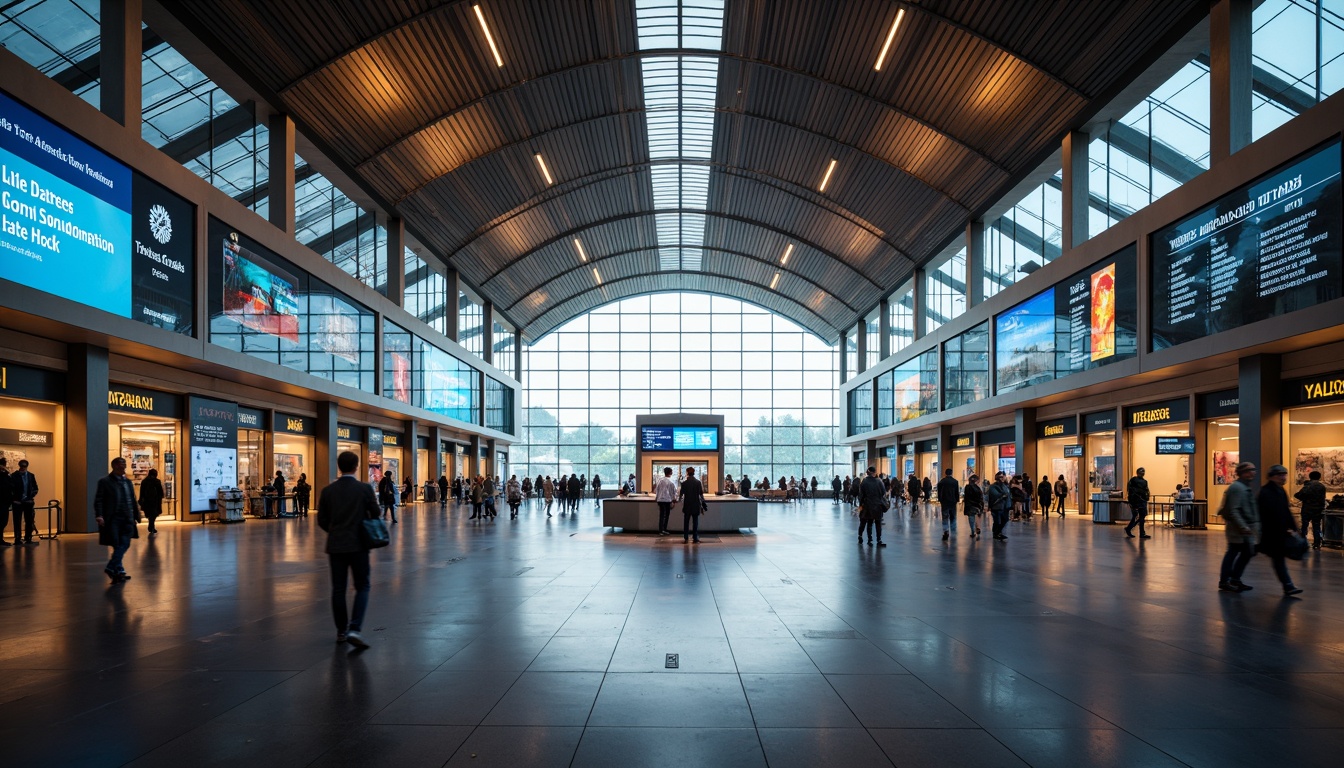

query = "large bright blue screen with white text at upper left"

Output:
[[0, 93, 196, 334]]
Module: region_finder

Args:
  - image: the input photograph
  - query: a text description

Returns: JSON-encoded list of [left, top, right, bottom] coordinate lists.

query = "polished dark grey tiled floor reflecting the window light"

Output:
[[0, 500, 1344, 768]]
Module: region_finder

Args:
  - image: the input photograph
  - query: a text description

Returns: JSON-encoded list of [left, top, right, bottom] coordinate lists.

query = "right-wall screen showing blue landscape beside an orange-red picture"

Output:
[[995, 246, 1138, 394]]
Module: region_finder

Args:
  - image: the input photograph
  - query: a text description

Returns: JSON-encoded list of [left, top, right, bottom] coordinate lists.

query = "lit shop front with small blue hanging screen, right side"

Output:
[[1117, 397, 1195, 503]]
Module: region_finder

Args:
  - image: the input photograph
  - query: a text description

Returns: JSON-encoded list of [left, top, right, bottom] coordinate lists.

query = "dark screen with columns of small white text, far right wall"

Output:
[[1152, 141, 1344, 350]]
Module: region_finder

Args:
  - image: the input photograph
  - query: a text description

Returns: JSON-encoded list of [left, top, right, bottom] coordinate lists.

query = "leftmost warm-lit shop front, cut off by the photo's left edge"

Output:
[[0, 363, 66, 533]]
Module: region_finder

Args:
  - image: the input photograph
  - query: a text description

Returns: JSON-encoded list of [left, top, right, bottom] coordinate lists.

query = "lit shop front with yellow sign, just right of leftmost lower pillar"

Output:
[[106, 383, 183, 521]]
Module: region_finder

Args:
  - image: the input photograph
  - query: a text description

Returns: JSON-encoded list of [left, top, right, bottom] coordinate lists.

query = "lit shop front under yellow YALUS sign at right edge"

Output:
[[1279, 371, 1344, 527]]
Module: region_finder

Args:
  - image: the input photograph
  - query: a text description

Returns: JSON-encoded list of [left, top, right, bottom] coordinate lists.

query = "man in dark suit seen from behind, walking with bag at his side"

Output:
[[317, 451, 382, 648]]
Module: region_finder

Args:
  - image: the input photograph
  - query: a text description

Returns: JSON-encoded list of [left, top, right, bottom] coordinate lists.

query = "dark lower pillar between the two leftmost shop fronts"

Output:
[[64, 344, 108, 533]]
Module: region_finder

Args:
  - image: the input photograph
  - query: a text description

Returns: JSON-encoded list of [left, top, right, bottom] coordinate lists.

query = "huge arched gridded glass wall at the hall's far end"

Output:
[[509, 293, 845, 480]]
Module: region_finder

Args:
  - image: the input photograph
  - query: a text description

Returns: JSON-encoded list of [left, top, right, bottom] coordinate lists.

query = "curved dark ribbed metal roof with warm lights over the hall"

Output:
[[167, 0, 1207, 342]]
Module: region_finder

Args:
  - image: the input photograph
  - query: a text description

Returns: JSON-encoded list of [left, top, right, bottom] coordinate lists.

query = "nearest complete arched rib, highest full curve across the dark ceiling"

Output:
[[360, 48, 1012, 176]]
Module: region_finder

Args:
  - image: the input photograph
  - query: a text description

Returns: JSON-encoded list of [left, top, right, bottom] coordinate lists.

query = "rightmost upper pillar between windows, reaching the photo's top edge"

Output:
[[1208, 0, 1254, 165]]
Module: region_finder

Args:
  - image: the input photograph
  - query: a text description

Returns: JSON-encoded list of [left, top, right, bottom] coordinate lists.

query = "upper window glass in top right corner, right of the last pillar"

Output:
[[1251, 0, 1344, 140]]
